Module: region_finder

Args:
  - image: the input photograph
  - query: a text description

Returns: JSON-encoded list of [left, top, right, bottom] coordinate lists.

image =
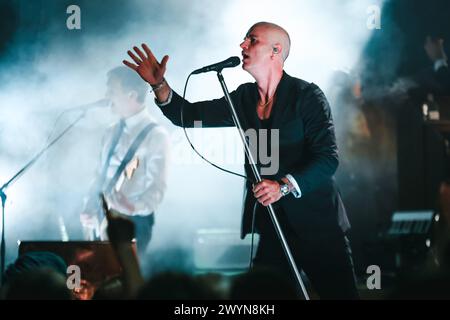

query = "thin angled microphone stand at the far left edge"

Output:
[[0, 110, 86, 284]]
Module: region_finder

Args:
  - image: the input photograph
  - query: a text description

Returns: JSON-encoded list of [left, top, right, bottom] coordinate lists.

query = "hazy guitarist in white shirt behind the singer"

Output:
[[80, 66, 169, 256]]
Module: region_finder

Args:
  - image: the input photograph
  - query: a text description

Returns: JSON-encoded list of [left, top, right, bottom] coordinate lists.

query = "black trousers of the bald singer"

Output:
[[253, 207, 359, 300]]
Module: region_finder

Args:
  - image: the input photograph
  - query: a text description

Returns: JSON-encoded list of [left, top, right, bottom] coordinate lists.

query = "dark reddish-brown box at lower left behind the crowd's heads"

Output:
[[19, 241, 136, 286]]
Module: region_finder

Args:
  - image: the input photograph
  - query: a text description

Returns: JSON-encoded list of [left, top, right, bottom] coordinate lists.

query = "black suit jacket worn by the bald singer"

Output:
[[161, 72, 350, 237]]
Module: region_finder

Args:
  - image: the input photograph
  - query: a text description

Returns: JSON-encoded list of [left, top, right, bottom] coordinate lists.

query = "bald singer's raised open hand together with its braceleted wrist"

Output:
[[123, 43, 170, 102]]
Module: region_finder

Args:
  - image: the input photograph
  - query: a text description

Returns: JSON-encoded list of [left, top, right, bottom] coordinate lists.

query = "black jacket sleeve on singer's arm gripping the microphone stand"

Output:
[[291, 84, 339, 195]]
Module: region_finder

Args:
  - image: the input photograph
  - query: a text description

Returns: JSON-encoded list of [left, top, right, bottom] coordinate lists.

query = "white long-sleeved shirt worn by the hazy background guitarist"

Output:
[[85, 108, 169, 216]]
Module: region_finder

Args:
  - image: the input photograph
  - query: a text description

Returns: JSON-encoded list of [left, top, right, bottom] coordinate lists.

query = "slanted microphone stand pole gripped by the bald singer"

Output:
[[217, 71, 309, 300]]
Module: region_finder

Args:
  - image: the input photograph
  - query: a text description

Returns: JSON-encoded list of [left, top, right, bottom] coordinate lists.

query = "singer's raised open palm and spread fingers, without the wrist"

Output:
[[123, 43, 169, 85]]
